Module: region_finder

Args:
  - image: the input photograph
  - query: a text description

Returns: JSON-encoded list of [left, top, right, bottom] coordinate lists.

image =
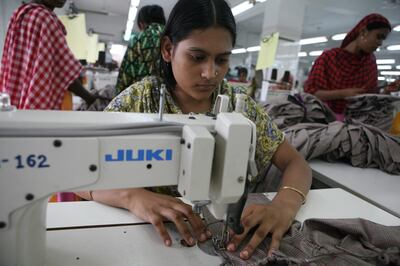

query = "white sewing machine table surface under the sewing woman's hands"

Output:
[[46, 188, 400, 266]]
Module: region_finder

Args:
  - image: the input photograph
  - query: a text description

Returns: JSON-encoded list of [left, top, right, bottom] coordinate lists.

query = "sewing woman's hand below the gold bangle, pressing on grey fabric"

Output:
[[227, 201, 297, 260]]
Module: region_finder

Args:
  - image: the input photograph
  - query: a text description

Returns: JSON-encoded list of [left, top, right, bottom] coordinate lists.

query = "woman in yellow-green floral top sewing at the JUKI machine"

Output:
[[79, 0, 311, 259]]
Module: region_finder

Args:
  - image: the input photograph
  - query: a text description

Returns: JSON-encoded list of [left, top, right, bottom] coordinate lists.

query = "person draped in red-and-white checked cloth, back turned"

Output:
[[0, 0, 95, 109]]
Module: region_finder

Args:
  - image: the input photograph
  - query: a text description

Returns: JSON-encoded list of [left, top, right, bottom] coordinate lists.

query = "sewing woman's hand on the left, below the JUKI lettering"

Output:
[[127, 188, 210, 246]]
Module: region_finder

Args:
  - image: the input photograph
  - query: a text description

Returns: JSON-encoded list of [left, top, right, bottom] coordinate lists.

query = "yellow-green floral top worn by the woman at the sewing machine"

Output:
[[105, 76, 284, 194]]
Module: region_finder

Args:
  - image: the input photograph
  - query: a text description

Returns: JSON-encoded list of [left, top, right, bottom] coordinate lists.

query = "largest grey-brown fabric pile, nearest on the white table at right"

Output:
[[285, 120, 400, 175]]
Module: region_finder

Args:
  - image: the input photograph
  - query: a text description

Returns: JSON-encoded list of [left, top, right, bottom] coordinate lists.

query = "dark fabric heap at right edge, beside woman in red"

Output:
[[345, 94, 400, 131]]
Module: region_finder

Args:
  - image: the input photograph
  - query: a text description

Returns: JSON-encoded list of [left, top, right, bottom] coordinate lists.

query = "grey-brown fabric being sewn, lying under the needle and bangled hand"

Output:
[[198, 194, 400, 266]]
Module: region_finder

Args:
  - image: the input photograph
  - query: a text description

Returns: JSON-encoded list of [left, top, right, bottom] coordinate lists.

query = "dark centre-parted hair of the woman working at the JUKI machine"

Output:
[[160, 0, 236, 89]]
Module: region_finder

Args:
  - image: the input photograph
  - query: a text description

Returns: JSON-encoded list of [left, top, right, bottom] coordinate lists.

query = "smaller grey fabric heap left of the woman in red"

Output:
[[264, 93, 336, 129]]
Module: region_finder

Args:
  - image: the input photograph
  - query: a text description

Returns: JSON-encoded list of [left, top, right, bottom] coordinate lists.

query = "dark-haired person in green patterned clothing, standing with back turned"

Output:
[[116, 5, 165, 94]]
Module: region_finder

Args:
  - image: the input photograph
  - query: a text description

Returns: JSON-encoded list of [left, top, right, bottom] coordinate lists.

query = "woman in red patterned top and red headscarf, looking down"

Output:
[[304, 14, 391, 115]]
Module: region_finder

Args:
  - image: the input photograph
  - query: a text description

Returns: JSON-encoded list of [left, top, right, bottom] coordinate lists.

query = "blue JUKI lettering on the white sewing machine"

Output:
[[105, 149, 172, 162]]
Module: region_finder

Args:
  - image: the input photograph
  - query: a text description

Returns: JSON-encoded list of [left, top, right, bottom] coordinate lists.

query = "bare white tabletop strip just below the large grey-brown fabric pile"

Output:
[[309, 160, 400, 217]]
